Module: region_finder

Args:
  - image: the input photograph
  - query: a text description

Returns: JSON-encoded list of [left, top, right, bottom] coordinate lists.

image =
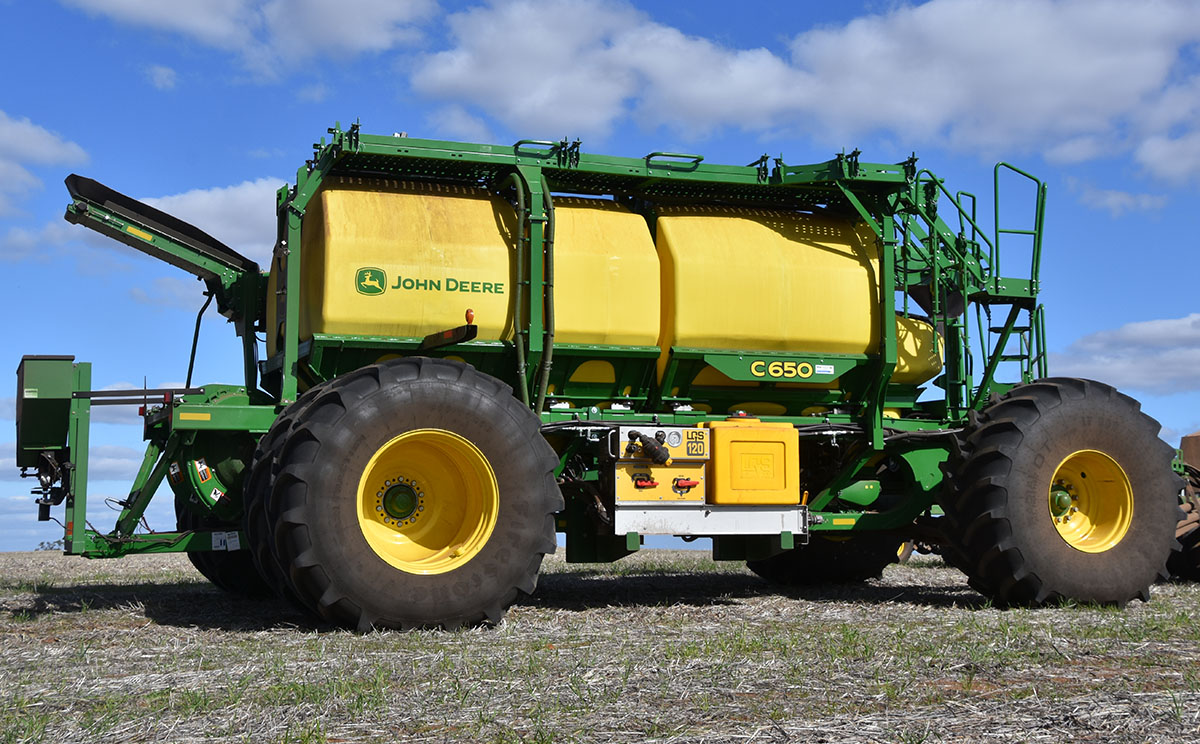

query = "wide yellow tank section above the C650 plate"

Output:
[[658, 206, 880, 372]]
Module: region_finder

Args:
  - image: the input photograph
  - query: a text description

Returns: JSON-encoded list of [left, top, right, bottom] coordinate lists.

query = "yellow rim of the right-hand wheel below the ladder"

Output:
[[1050, 450, 1133, 553]]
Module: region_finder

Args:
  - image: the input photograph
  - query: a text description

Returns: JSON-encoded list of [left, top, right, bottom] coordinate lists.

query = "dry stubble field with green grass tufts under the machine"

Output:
[[0, 551, 1200, 743]]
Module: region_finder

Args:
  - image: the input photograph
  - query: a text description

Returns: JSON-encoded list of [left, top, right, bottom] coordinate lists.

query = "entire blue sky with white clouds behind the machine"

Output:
[[0, 0, 1200, 550]]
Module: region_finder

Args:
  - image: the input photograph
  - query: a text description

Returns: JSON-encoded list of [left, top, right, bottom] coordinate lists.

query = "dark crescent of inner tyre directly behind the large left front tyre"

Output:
[[242, 385, 320, 608]]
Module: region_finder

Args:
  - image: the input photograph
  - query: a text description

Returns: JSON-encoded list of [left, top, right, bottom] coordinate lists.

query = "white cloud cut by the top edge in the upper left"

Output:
[[64, 0, 437, 77]]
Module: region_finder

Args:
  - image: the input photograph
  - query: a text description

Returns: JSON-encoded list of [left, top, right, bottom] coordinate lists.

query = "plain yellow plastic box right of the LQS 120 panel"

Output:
[[706, 418, 800, 504]]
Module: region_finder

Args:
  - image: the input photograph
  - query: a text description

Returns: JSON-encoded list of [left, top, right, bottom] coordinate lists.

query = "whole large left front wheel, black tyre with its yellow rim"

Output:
[[268, 358, 563, 631]]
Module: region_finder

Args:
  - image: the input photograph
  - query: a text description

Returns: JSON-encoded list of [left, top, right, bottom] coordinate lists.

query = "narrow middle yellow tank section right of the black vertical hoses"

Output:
[[554, 197, 659, 348]]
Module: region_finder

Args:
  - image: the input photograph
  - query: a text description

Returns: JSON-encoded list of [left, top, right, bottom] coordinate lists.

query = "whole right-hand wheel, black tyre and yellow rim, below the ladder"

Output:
[[942, 378, 1182, 606]]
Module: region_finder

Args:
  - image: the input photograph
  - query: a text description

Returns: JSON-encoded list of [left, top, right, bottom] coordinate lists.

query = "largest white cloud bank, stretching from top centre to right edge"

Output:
[[410, 0, 1200, 175]]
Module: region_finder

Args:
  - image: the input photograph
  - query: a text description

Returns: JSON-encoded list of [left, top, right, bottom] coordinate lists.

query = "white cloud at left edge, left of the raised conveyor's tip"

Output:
[[0, 110, 88, 216]]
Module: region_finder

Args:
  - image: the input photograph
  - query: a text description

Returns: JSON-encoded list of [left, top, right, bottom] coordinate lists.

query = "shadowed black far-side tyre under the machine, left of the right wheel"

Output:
[[746, 534, 902, 587]]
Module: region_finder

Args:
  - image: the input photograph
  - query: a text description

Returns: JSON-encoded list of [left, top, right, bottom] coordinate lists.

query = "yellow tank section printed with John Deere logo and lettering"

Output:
[[300, 178, 516, 352]]
